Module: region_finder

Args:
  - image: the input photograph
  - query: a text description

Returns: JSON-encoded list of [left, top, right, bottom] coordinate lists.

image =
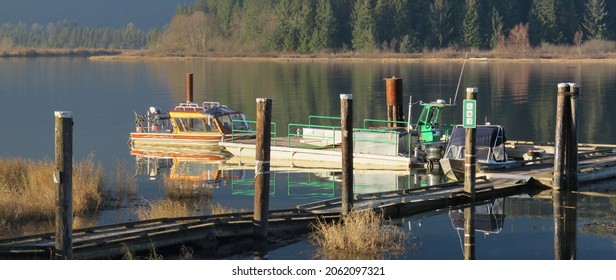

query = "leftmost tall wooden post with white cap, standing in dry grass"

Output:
[[53, 111, 73, 260]]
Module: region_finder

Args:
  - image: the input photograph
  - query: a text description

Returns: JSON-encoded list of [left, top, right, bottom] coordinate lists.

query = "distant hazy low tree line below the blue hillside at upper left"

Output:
[[0, 21, 158, 49]]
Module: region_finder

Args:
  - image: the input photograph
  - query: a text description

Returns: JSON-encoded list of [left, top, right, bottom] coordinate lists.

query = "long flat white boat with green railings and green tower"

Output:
[[219, 99, 452, 170]]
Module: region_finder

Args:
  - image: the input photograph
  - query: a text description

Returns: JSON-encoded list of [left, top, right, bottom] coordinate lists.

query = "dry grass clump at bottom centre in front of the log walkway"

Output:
[[311, 211, 409, 259]]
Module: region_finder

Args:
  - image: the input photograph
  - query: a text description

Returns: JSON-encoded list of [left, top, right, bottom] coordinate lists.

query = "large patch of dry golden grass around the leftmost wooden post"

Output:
[[0, 155, 104, 223]]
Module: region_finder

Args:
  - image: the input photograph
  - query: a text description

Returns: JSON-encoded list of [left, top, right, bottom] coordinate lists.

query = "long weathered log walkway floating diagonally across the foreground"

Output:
[[0, 176, 535, 259]]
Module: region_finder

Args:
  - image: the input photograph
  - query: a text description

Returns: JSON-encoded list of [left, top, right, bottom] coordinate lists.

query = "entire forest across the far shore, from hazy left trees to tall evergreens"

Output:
[[0, 0, 616, 55]]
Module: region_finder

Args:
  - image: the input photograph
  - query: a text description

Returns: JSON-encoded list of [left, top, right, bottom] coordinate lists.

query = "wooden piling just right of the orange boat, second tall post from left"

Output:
[[253, 98, 272, 239]]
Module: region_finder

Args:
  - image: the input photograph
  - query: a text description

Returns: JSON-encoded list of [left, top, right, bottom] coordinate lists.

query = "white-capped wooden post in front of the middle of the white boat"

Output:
[[340, 94, 353, 215]]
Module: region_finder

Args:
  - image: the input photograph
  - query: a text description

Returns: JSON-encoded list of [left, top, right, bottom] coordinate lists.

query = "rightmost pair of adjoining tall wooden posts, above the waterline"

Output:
[[552, 83, 579, 190]]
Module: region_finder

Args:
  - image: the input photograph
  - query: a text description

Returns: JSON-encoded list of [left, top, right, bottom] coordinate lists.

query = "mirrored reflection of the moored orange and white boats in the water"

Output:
[[133, 151, 447, 206]]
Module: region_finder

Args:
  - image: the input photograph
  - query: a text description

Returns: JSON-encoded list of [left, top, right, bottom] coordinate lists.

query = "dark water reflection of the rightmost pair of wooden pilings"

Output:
[[552, 191, 577, 260]]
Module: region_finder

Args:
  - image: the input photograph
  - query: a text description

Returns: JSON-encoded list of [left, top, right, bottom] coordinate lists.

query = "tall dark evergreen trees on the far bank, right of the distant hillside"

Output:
[[163, 0, 616, 53]]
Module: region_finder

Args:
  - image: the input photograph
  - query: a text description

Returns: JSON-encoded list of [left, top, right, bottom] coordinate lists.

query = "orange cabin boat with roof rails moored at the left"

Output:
[[129, 102, 255, 154]]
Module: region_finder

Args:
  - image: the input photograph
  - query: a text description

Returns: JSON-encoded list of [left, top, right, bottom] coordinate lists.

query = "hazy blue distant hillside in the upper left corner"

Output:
[[0, 0, 194, 31]]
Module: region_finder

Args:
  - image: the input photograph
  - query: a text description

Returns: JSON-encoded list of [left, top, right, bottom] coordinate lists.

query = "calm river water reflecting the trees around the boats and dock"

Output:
[[0, 58, 616, 259]]
